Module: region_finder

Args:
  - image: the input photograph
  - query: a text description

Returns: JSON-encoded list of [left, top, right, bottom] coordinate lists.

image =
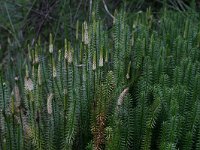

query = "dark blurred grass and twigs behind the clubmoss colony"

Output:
[[0, 0, 200, 68]]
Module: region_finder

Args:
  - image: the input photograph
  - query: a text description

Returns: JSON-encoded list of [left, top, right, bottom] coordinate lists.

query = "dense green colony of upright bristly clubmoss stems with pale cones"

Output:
[[0, 9, 200, 150]]
